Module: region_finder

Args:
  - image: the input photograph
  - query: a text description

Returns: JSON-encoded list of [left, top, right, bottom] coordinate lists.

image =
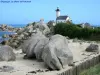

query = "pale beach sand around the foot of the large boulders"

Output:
[[0, 40, 97, 75]]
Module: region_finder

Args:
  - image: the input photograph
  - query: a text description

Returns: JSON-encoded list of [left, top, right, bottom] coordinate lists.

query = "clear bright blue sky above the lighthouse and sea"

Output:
[[0, 0, 100, 25]]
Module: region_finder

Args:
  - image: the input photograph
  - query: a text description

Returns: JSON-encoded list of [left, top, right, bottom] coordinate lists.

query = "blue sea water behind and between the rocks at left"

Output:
[[0, 24, 27, 43]]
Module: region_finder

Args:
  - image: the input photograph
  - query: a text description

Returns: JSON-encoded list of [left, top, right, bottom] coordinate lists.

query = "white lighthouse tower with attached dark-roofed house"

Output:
[[56, 7, 71, 23]]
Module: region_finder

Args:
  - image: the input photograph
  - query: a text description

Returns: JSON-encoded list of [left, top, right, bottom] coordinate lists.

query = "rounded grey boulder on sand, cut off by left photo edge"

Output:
[[0, 45, 16, 61]]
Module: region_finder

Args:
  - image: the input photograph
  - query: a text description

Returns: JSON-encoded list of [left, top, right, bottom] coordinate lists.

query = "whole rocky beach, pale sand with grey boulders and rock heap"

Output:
[[0, 22, 100, 75]]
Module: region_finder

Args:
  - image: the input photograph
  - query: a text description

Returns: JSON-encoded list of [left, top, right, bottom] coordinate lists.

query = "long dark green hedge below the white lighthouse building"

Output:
[[54, 23, 100, 41]]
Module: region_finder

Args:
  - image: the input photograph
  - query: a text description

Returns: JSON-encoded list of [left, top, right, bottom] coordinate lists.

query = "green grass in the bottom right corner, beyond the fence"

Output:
[[80, 64, 100, 75]]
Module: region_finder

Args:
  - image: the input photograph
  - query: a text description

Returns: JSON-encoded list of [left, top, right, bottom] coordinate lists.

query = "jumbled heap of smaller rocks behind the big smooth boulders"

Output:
[[9, 22, 50, 48]]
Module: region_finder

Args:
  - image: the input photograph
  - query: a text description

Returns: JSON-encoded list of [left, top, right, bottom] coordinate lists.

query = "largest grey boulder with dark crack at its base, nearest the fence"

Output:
[[42, 34, 73, 70]]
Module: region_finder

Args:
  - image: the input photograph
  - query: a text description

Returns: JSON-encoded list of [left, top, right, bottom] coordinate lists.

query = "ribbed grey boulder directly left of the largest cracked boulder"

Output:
[[22, 30, 49, 60]]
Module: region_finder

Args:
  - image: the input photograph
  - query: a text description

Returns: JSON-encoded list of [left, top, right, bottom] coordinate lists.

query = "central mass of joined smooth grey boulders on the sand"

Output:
[[22, 33, 73, 70]]
